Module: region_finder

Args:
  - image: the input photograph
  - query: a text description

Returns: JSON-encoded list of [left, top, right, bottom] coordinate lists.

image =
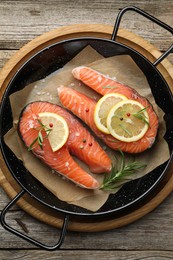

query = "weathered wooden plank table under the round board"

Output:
[[0, 0, 173, 260]]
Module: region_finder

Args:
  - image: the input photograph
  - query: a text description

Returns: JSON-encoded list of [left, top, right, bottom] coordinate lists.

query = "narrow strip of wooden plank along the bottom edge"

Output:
[[0, 250, 173, 260]]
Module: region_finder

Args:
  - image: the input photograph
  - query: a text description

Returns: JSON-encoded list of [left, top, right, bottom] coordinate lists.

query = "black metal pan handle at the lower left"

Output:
[[0, 190, 69, 251]]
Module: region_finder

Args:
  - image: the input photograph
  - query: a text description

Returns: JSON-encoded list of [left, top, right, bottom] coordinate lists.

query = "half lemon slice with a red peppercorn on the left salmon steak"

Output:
[[38, 112, 69, 152]]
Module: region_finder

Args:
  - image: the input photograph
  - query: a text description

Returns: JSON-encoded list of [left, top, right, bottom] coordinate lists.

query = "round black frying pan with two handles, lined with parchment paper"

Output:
[[0, 7, 173, 250]]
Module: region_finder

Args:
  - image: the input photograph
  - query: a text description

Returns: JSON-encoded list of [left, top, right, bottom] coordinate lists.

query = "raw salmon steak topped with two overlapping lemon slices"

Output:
[[58, 67, 158, 153]]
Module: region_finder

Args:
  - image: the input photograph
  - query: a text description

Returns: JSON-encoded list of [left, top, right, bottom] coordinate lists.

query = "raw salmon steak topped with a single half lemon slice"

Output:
[[18, 101, 111, 189]]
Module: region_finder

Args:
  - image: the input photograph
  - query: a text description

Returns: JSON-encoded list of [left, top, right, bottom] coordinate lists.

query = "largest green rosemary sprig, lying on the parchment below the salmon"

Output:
[[100, 151, 146, 192]]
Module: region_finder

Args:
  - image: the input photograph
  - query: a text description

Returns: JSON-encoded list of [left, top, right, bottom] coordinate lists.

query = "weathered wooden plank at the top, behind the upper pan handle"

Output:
[[0, 0, 173, 50]]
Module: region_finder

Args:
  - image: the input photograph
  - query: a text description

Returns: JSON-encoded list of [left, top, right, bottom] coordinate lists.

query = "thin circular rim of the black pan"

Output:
[[0, 37, 173, 217]]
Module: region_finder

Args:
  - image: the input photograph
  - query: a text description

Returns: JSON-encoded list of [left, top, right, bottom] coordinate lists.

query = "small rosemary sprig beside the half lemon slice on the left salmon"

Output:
[[28, 119, 52, 151]]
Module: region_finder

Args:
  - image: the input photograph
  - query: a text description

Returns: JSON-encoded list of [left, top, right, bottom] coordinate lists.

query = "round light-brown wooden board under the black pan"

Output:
[[0, 24, 173, 232]]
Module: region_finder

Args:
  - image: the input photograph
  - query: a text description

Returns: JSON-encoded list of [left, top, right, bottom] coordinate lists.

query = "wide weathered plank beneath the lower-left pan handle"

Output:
[[0, 195, 173, 251]]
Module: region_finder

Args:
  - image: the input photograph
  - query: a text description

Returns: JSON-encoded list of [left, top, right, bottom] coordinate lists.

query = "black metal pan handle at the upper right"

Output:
[[111, 6, 173, 66]]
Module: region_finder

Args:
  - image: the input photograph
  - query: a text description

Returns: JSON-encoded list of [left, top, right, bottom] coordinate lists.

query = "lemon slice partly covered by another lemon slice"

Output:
[[94, 93, 127, 134]]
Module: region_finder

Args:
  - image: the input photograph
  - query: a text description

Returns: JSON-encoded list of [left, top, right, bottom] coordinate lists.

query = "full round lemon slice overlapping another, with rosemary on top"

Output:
[[107, 99, 149, 142]]
